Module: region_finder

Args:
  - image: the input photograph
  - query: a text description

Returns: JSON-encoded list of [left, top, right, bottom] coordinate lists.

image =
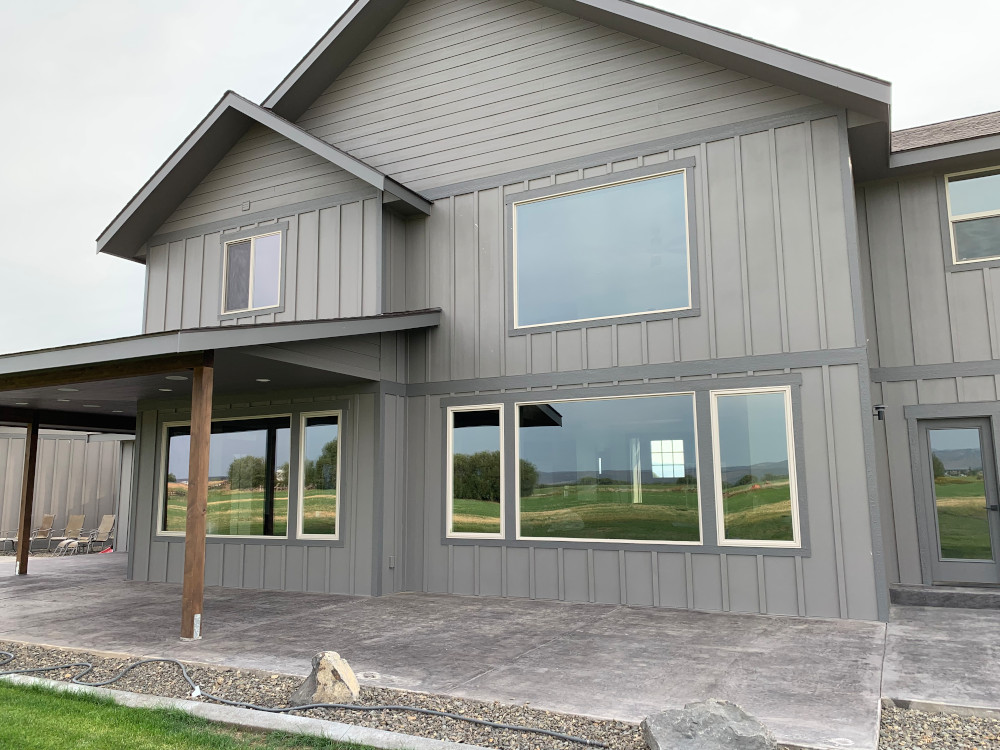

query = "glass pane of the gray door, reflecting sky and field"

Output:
[[928, 428, 993, 560]]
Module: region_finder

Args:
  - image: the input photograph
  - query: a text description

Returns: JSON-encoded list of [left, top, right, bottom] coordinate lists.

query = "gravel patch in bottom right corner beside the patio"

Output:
[[878, 708, 1000, 750]]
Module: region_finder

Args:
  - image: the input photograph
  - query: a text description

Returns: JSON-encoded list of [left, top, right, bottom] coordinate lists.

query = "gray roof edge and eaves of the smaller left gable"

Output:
[[97, 91, 430, 263]]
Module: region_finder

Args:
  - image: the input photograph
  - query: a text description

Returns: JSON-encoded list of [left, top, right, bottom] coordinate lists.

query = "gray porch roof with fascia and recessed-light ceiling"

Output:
[[0, 310, 440, 431]]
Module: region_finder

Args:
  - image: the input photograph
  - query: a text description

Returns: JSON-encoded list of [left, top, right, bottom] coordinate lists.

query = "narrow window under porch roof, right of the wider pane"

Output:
[[299, 412, 341, 538]]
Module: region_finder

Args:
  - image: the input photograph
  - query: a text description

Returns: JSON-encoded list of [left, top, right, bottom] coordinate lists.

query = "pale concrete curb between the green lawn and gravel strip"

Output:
[[0, 675, 492, 750]]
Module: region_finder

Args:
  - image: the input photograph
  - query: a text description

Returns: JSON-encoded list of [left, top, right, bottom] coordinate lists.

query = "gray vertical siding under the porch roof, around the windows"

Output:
[[129, 389, 378, 595]]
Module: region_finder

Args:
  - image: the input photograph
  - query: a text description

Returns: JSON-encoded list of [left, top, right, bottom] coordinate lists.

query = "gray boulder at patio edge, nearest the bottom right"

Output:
[[642, 700, 778, 750]]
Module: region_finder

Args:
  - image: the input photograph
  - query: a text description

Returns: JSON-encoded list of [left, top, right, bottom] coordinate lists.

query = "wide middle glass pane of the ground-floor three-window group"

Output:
[[518, 394, 701, 542]]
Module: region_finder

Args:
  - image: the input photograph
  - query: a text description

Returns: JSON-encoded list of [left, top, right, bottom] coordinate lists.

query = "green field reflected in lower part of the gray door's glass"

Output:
[[934, 477, 993, 560]]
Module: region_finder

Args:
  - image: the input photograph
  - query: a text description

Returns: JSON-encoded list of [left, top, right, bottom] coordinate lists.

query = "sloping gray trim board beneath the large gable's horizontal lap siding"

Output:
[[424, 104, 843, 201]]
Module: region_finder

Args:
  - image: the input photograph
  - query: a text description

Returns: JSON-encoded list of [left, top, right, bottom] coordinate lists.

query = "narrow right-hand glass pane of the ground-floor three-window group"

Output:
[[716, 392, 794, 542]]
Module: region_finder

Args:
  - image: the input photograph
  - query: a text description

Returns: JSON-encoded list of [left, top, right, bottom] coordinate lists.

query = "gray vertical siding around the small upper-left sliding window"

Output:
[[144, 195, 382, 333]]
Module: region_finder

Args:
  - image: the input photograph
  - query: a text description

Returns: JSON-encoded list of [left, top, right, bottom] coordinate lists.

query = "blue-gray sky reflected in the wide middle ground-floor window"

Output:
[[518, 394, 695, 477]]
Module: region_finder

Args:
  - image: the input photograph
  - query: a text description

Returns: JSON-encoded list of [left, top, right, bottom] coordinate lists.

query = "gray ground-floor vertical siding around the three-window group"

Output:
[[403, 365, 878, 619]]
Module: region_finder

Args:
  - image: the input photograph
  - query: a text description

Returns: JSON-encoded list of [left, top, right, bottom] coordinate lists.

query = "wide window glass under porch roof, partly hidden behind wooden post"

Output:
[[161, 417, 291, 537]]
